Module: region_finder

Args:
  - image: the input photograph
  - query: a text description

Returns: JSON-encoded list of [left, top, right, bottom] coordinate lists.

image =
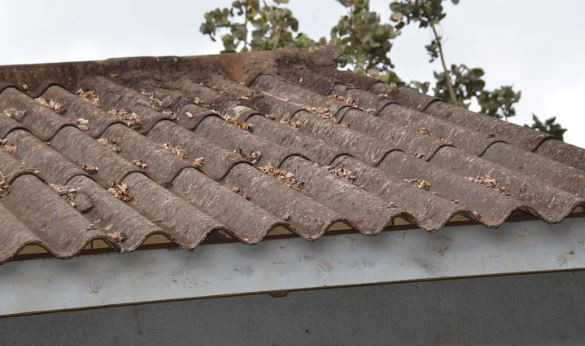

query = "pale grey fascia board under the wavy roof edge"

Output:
[[0, 217, 585, 316]]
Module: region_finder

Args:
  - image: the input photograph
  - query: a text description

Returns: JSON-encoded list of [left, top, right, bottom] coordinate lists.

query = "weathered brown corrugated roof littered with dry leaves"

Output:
[[0, 48, 585, 262]]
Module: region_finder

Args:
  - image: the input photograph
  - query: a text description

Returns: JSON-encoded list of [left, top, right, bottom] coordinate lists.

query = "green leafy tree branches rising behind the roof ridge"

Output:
[[199, 0, 566, 139]]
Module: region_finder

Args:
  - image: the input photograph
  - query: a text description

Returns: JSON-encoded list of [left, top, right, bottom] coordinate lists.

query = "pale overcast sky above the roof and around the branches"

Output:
[[0, 0, 585, 147]]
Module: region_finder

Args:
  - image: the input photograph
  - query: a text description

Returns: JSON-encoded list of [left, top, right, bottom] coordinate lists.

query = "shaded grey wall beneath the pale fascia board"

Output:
[[0, 272, 585, 345]]
